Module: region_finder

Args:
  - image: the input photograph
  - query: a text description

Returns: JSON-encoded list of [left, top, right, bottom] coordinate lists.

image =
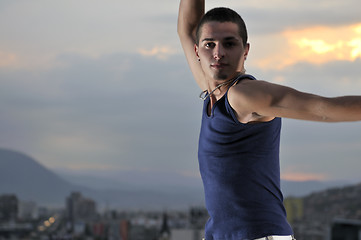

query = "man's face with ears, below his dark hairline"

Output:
[[195, 22, 249, 80]]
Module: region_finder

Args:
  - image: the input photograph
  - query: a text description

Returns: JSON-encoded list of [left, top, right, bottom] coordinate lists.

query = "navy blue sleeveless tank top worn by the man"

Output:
[[198, 75, 293, 240]]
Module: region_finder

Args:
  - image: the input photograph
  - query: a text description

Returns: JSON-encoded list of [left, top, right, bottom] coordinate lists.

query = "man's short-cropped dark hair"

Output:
[[196, 7, 248, 46]]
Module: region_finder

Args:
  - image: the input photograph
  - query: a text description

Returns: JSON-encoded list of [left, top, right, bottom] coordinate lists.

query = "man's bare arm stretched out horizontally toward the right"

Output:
[[228, 80, 361, 123]]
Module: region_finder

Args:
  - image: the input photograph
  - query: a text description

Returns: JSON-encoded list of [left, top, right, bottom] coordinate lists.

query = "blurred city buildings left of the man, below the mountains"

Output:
[[0, 192, 208, 240]]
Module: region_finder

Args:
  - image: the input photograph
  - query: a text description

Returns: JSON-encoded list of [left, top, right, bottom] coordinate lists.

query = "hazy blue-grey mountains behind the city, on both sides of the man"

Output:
[[0, 149, 354, 209]]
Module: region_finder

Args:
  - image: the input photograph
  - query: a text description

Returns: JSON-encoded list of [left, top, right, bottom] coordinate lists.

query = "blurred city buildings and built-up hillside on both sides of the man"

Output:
[[0, 184, 361, 240]]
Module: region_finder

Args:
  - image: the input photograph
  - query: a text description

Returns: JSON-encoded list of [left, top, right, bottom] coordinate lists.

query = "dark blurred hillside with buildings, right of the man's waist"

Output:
[[286, 183, 361, 240]]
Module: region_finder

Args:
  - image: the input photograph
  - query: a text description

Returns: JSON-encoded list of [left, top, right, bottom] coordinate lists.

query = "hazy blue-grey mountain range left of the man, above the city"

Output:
[[0, 149, 202, 209]]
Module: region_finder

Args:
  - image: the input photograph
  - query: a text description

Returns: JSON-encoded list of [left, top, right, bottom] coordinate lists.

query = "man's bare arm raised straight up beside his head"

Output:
[[178, 0, 207, 90]]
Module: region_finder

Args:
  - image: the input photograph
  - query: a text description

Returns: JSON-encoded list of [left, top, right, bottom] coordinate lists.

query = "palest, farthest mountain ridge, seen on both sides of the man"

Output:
[[55, 169, 351, 199]]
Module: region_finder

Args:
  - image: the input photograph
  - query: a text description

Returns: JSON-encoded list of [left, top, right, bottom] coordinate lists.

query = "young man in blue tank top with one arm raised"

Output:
[[178, 0, 361, 240]]
